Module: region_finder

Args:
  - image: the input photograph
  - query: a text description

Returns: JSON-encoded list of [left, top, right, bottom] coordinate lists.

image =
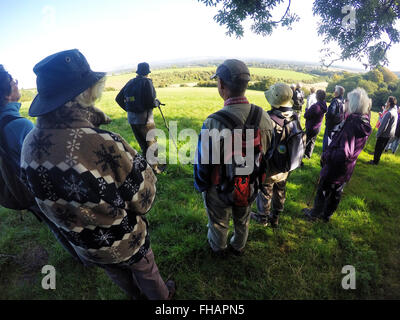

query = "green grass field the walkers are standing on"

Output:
[[0, 88, 400, 299]]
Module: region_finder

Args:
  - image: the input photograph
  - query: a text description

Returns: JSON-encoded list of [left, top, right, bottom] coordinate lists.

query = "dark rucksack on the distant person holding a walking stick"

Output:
[[124, 77, 153, 113]]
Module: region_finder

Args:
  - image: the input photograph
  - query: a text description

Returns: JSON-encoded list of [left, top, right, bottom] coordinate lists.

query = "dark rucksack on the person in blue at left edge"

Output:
[[0, 115, 36, 210]]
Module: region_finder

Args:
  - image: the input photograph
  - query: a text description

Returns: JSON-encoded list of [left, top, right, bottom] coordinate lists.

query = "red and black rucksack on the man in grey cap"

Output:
[[209, 105, 266, 207]]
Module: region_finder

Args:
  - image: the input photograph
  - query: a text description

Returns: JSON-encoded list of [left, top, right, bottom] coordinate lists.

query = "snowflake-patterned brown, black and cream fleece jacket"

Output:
[[21, 103, 156, 264]]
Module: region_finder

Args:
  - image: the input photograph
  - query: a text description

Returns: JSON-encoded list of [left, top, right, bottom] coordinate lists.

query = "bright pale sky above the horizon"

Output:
[[0, 0, 400, 88]]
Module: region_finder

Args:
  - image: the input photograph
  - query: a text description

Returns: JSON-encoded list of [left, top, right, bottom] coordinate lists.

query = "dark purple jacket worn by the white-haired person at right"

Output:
[[320, 113, 372, 184]]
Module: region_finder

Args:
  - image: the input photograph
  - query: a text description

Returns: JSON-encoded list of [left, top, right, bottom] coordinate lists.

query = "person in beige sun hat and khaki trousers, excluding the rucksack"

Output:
[[251, 83, 298, 228]]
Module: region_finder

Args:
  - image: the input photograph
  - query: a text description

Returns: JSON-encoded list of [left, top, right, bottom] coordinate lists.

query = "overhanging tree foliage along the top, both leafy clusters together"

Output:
[[198, 0, 400, 69]]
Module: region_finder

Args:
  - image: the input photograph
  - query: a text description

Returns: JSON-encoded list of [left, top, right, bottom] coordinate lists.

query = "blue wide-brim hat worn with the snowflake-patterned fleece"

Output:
[[29, 49, 106, 117]]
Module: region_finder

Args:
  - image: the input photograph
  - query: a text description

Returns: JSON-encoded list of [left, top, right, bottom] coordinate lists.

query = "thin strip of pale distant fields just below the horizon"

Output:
[[106, 67, 316, 89]]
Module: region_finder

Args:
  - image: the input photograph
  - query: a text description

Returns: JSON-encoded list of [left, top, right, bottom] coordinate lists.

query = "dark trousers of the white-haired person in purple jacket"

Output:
[[312, 181, 346, 219]]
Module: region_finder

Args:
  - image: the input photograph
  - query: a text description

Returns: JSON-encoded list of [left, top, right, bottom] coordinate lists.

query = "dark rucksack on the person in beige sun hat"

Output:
[[268, 110, 306, 173]]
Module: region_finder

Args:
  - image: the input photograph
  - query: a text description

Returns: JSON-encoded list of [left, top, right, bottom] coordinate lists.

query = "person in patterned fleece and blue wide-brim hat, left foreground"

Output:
[[21, 49, 175, 300]]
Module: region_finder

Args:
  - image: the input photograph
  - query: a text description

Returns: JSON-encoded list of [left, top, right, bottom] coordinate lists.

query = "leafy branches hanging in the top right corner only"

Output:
[[313, 0, 400, 67]]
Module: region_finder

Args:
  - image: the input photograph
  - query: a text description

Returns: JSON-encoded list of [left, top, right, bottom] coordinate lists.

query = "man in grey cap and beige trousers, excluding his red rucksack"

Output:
[[194, 59, 273, 256]]
